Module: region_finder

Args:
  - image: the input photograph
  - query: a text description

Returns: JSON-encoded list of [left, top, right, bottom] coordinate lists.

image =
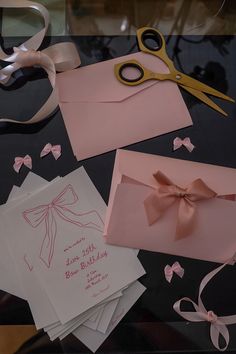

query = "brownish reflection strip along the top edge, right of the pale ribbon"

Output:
[[66, 0, 236, 35]]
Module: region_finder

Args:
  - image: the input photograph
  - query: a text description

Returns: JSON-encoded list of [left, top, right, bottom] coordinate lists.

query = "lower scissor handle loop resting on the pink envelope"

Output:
[[114, 60, 155, 86]]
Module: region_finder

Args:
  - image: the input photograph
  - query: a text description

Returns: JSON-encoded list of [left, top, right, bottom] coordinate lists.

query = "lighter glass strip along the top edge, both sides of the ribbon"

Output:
[[1, 0, 236, 37]]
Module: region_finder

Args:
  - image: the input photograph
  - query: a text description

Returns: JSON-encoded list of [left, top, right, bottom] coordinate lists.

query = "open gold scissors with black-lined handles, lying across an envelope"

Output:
[[115, 27, 235, 116]]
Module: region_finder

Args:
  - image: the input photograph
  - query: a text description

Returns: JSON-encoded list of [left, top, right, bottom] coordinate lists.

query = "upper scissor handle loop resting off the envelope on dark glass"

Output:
[[137, 27, 175, 70]]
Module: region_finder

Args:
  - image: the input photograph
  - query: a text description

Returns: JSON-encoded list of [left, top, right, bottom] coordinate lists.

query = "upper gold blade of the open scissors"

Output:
[[179, 73, 235, 102]]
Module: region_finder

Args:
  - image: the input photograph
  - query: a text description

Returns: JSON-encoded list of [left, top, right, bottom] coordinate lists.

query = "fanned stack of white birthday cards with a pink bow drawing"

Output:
[[0, 168, 145, 352]]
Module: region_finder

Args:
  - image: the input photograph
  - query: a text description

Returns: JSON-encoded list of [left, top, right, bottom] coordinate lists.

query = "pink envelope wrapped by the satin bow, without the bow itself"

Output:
[[105, 150, 236, 263]]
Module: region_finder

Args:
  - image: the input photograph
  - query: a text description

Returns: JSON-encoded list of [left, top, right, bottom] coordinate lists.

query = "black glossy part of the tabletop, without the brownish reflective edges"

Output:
[[0, 31, 236, 354]]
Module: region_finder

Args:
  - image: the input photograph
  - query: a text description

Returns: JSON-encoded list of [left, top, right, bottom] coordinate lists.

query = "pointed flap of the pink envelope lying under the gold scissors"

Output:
[[57, 52, 169, 102]]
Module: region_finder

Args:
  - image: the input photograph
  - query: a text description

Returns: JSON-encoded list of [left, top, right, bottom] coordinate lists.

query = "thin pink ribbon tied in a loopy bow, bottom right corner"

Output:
[[173, 255, 236, 351]]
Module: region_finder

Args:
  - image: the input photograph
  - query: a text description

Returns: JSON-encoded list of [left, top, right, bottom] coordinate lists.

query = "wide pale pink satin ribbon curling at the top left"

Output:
[[0, 0, 81, 124]]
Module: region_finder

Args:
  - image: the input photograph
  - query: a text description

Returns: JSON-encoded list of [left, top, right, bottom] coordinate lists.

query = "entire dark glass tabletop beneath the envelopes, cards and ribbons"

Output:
[[0, 0, 236, 354]]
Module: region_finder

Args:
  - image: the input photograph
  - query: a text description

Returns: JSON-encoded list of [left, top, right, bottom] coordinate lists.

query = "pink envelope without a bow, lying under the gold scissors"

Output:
[[57, 52, 192, 160]]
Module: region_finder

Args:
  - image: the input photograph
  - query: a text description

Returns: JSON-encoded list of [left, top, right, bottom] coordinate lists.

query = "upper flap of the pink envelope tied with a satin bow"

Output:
[[116, 150, 236, 195]]
